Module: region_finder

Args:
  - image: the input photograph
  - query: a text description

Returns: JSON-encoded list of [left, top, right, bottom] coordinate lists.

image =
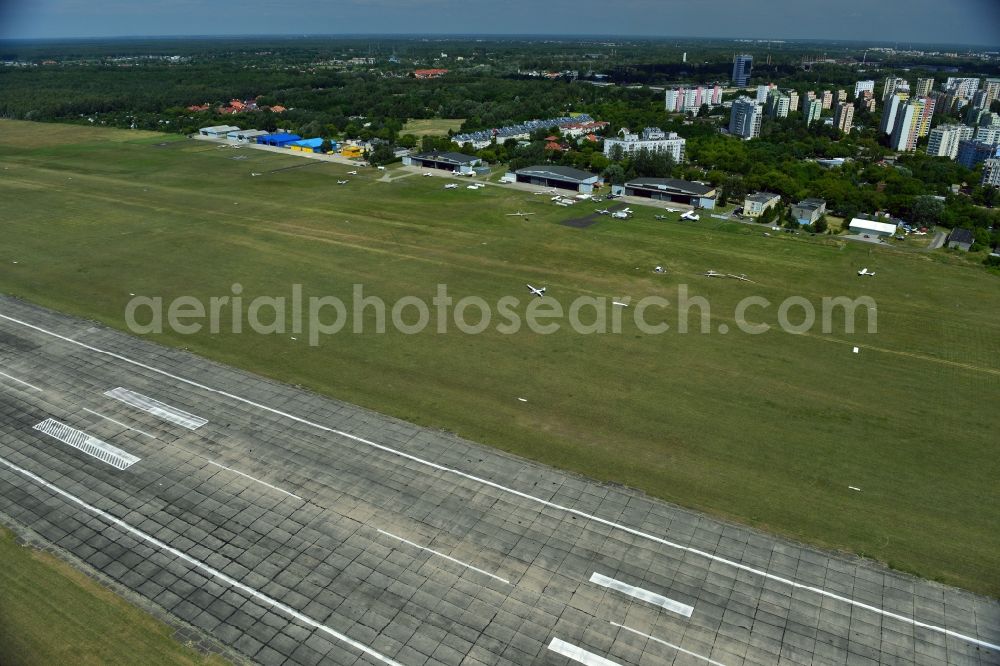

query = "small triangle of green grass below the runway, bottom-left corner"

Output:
[[0, 528, 226, 666]]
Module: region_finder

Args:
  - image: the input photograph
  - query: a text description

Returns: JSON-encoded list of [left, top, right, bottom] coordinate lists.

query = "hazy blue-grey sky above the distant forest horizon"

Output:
[[0, 0, 1000, 49]]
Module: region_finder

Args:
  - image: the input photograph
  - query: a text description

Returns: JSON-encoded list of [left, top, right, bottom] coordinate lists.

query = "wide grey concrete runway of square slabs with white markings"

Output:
[[0, 297, 1000, 666]]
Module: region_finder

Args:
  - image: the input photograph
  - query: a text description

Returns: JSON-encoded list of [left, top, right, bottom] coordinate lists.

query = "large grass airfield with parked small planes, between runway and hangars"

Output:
[[0, 121, 1000, 595]]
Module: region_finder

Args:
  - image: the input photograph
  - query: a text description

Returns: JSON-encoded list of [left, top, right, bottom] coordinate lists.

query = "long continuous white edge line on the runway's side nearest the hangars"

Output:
[[0, 314, 1000, 650]]
